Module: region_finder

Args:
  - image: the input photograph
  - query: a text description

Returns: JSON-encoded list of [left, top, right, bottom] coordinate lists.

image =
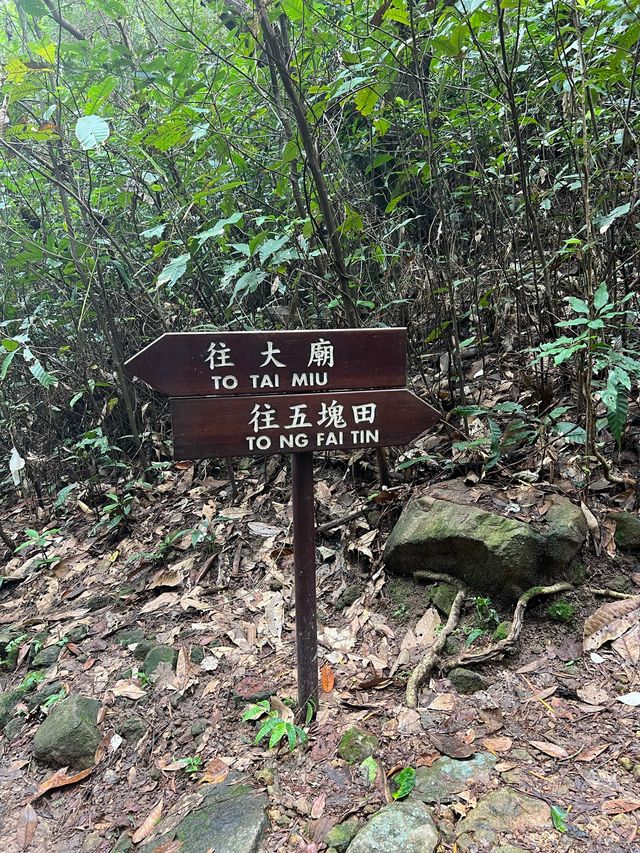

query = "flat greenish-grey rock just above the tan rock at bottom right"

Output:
[[412, 752, 497, 803]]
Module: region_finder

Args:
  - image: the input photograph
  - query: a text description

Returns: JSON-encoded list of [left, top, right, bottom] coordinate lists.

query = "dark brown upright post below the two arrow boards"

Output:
[[291, 452, 318, 714]]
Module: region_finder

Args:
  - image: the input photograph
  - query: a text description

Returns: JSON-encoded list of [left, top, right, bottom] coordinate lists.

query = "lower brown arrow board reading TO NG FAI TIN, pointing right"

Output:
[[171, 389, 440, 460]]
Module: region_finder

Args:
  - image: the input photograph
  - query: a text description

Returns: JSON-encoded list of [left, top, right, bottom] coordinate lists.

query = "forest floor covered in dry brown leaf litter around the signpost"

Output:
[[0, 456, 640, 853]]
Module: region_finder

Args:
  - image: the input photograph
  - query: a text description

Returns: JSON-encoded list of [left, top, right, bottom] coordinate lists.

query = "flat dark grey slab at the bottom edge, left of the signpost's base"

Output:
[[139, 773, 269, 853]]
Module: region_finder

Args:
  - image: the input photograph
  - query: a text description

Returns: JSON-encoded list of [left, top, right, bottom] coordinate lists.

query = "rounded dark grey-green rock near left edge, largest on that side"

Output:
[[33, 694, 101, 770]]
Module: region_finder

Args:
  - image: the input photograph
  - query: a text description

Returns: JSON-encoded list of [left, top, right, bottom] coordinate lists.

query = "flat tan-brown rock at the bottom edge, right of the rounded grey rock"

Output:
[[456, 788, 552, 852]]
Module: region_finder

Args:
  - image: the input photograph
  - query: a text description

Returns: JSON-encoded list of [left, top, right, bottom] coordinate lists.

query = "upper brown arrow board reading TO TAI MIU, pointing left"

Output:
[[127, 328, 407, 397]]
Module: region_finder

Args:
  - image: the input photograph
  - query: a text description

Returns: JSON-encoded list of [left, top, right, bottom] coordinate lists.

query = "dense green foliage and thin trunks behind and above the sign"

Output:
[[0, 0, 640, 488]]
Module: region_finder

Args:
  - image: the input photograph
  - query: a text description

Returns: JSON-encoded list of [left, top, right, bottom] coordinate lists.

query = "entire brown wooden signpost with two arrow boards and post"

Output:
[[127, 329, 439, 709]]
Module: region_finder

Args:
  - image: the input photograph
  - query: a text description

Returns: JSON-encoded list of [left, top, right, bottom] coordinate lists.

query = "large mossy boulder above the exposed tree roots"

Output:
[[384, 495, 587, 598]]
